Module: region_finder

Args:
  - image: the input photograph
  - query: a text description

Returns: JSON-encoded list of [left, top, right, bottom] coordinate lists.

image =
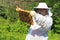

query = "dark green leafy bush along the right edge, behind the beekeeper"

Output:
[[52, 3, 60, 33]]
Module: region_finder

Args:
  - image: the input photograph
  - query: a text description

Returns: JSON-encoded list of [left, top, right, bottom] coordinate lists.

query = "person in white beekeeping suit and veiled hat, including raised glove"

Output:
[[26, 2, 53, 40]]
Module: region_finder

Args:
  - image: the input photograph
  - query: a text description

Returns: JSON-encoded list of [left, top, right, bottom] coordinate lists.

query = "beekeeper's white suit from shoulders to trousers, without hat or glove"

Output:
[[26, 14, 52, 40]]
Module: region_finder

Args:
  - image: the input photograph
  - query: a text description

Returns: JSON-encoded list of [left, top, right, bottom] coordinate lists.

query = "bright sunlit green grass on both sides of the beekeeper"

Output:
[[0, 17, 60, 40]]
